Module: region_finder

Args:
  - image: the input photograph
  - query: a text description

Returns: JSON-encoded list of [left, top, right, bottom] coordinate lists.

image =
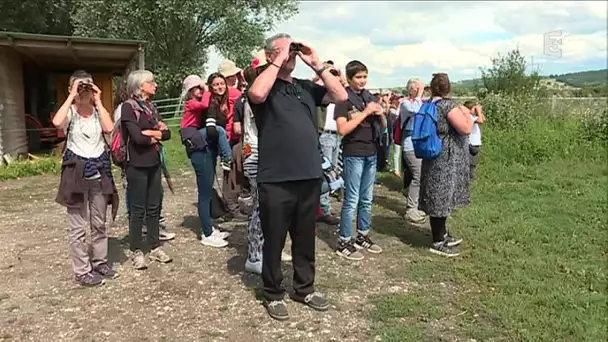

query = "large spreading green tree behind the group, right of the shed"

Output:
[[72, 0, 298, 97]]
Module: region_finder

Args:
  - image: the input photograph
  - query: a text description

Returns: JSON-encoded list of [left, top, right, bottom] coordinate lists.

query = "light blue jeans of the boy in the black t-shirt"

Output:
[[340, 155, 376, 240]]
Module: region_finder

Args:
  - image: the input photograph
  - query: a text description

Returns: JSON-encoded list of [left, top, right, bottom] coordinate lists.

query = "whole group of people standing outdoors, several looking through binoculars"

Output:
[[53, 34, 483, 320]]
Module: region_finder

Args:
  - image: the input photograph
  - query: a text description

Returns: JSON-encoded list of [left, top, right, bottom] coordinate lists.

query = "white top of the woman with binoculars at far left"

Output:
[[63, 106, 105, 158]]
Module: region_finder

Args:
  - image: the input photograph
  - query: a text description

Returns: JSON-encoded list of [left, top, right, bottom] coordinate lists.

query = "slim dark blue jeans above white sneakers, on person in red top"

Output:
[[190, 146, 217, 236]]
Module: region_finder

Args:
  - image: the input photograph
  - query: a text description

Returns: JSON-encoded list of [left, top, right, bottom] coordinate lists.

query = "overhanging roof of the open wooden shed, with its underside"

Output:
[[0, 32, 146, 73]]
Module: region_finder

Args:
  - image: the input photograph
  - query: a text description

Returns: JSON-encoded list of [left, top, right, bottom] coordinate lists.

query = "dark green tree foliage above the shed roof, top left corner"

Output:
[[0, 0, 73, 35]]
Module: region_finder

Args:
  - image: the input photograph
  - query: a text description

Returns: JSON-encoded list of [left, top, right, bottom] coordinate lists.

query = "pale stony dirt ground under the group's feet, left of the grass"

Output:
[[0, 173, 412, 341]]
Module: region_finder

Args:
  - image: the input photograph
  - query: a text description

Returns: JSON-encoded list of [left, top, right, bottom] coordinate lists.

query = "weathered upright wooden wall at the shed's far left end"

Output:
[[0, 47, 27, 157]]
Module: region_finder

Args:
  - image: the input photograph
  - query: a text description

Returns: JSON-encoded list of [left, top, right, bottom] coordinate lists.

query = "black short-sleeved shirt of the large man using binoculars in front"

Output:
[[251, 78, 327, 183]]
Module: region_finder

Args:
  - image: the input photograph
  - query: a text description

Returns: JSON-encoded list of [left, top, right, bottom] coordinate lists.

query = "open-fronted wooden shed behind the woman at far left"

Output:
[[0, 32, 146, 161]]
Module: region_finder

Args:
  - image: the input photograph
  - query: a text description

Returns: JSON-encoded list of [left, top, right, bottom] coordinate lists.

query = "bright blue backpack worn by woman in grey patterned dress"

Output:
[[412, 100, 442, 159]]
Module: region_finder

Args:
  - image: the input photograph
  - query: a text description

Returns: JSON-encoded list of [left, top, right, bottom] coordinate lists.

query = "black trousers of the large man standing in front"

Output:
[[258, 179, 321, 301]]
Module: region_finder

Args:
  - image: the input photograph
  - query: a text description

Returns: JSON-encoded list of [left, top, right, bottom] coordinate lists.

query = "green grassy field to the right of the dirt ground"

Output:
[[370, 122, 608, 341]]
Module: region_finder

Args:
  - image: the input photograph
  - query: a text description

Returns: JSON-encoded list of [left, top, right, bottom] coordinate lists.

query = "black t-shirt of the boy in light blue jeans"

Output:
[[334, 89, 376, 157]]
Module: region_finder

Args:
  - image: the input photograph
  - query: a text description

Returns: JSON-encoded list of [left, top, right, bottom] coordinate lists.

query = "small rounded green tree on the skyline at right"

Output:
[[481, 49, 541, 95]]
